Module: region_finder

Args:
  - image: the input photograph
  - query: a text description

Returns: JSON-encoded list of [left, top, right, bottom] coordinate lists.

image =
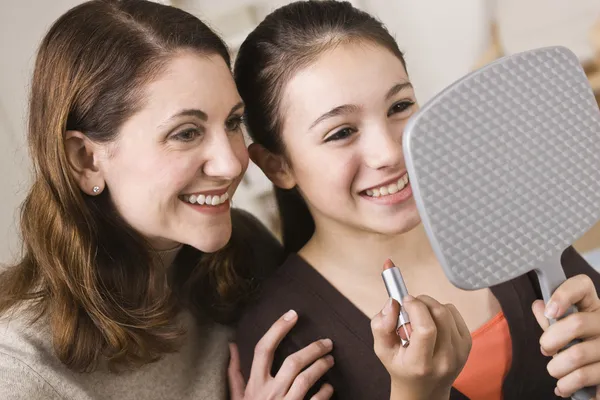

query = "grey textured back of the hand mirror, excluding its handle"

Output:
[[403, 47, 600, 289]]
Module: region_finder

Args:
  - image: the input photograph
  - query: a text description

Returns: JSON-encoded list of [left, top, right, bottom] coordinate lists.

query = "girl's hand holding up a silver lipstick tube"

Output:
[[371, 260, 471, 400]]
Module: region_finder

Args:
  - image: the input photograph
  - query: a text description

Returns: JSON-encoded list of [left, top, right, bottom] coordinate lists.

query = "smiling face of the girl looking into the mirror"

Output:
[[282, 43, 420, 238]]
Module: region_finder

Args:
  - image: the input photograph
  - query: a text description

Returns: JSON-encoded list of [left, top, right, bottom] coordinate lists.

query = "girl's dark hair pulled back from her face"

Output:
[[234, 1, 406, 252]]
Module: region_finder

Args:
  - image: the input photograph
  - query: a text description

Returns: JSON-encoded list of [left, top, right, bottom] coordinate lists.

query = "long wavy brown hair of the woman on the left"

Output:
[[0, 0, 260, 371]]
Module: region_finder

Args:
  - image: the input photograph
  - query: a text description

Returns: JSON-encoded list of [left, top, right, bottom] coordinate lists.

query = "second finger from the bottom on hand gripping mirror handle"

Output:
[[547, 339, 600, 379]]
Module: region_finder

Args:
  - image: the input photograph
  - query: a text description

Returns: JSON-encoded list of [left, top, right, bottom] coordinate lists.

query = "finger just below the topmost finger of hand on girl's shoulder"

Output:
[[275, 339, 333, 393]]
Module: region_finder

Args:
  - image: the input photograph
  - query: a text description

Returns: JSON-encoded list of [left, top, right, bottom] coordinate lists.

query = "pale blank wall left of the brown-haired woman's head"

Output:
[[0, 0, 88, 263]]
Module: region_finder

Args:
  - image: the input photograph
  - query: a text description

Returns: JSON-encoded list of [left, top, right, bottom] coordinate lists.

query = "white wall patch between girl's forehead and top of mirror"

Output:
[[361, 0, 492, 105]]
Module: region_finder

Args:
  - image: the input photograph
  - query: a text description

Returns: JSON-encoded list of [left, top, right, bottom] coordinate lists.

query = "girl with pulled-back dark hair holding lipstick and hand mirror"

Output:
[[234, 1, 600, 400]]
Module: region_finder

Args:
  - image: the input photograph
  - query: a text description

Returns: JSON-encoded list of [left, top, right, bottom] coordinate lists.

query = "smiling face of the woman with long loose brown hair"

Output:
[[99, 52, 248, 252]]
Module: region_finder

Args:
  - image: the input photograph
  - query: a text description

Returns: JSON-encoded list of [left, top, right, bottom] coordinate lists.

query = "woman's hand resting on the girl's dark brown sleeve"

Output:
[[228, 311, 333, 400]]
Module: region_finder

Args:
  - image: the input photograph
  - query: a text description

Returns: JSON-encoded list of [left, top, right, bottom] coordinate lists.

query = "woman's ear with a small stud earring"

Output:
[[65, 131, 105, 196]]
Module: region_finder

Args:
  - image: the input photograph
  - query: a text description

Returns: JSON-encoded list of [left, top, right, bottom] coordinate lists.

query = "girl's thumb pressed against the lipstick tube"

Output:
[[371, 298, 402, 364]]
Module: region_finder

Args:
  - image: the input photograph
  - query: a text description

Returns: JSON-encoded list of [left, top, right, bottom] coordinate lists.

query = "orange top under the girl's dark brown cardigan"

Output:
[[454, 311, 512, 400]]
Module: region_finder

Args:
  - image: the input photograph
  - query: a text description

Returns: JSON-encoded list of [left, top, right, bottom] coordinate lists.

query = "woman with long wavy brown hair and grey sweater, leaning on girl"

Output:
[[0, 0, 332, 400]]
